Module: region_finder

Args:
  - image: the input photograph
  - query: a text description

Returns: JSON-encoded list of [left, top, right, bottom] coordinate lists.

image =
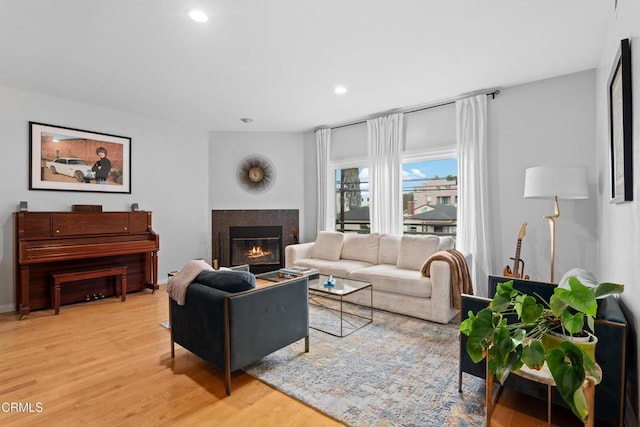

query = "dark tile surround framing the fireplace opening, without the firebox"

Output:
[[211, 209, 300, 267]]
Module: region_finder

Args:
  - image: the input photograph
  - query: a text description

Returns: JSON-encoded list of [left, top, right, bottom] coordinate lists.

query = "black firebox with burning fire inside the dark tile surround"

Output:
[[229, 226, 282, 272]]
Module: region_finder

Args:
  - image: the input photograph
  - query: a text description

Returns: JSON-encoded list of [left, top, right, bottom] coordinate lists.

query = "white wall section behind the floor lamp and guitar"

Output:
[[488, 70, 598, 290]]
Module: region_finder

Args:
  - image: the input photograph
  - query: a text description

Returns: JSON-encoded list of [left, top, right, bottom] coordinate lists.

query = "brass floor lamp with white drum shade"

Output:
[[524, 166, 589, 283]]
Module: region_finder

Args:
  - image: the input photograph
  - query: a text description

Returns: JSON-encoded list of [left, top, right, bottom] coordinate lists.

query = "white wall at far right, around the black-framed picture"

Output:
[[596, 0, 640, 418]]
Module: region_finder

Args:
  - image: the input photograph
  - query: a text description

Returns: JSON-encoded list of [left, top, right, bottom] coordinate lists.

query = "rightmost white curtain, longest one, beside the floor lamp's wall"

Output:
[[456, 95, 495, 296]]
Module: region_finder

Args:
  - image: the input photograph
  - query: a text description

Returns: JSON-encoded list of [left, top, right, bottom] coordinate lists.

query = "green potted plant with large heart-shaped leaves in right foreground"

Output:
[[460, 277, 624, 422]]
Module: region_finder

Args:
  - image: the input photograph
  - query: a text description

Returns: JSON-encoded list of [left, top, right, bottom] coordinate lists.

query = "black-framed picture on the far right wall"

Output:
[[609, 39, 633, 203]]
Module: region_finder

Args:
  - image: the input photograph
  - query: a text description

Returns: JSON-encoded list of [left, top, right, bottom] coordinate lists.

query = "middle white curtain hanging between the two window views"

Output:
[[367, 114, 404, 234]]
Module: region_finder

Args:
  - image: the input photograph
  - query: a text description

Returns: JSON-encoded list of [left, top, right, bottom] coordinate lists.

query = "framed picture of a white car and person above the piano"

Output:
[[29, 122, 131, 194]]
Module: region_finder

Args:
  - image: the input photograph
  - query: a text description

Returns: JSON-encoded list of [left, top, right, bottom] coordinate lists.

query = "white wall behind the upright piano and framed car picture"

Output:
[[0, 87, 210, 312]]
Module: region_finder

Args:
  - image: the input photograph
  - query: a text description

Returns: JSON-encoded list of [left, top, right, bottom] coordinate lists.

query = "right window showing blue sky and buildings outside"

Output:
[[402, 157, 458, 236]]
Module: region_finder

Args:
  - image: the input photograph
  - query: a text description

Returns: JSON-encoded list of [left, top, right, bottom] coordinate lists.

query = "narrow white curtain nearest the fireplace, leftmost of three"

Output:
[[316, 128, 335, 231]]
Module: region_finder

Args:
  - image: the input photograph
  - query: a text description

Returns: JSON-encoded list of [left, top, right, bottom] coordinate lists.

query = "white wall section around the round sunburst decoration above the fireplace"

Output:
[[207, 132, 308, 243]]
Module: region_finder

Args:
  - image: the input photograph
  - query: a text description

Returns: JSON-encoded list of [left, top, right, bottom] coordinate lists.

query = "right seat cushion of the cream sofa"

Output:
[[349, 264, 432, 298]]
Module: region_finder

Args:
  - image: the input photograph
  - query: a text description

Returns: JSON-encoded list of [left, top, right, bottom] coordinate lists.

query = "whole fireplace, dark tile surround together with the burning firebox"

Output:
[[211, 209, 299, 273]]
